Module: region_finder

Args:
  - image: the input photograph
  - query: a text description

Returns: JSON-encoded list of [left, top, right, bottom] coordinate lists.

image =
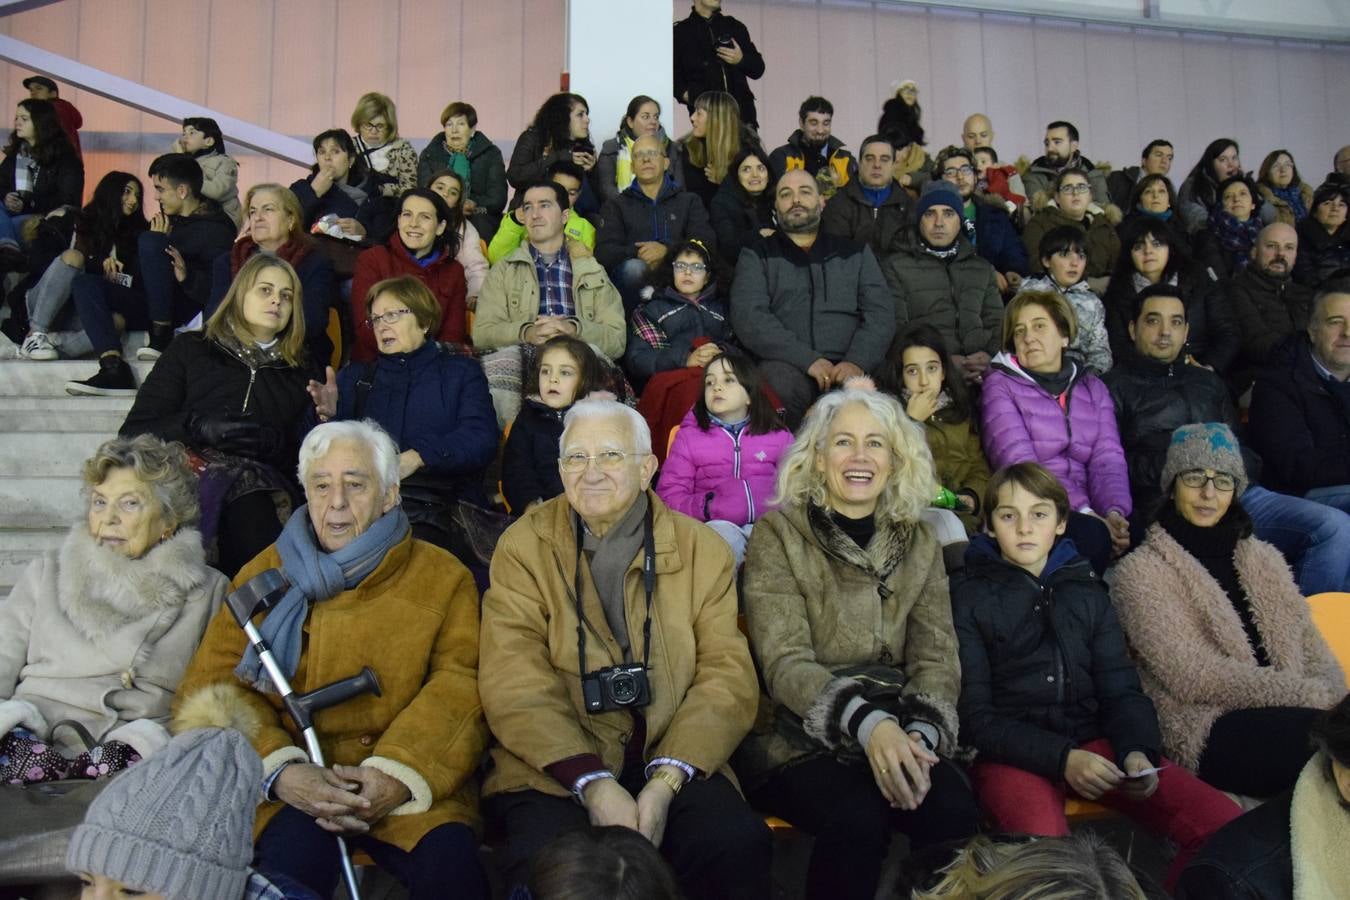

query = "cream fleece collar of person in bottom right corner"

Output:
[[1289, 753, 1350, 900]]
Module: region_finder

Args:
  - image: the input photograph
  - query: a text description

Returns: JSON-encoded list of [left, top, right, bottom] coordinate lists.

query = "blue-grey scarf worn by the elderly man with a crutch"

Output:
[[235, 505, 410, 694]]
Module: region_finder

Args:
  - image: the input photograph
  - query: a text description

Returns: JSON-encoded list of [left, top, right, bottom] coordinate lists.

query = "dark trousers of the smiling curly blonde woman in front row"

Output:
[[751, 757, 980, 900]]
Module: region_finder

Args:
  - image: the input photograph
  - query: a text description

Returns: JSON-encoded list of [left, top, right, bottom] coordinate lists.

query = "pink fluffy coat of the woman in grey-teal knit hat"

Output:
[[1111, 525, 1346, 769]]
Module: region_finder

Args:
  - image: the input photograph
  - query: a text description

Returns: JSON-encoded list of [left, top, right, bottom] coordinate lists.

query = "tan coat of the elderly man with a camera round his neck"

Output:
[[479, 493, 756, 796]]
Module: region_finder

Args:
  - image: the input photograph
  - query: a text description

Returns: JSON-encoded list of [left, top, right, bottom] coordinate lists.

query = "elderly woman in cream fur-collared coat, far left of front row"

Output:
[[0, 434, 227, 784]]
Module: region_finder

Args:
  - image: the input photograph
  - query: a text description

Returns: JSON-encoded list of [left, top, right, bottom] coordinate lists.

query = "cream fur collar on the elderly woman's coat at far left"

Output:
[[57, 522, 208, 641]]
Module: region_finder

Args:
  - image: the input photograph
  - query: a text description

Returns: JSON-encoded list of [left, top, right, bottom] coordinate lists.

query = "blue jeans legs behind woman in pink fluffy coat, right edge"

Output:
[[1242, 484, 1350, 595]]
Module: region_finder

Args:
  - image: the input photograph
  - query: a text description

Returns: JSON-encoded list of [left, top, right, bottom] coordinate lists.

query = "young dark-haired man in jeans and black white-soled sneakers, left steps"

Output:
[[66, 154, 235, 395]]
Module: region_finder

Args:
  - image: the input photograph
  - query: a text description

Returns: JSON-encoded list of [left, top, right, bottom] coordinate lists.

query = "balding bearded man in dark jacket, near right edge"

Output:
[[1227, 223, 1312, 394]]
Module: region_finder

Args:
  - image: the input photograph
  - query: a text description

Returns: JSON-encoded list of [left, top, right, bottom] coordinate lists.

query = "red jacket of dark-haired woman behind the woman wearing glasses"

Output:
[[351, 231, 470, 363]]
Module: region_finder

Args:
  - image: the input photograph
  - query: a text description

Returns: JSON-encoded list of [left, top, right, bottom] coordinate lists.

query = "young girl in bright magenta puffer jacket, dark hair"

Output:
[[656, 352, 792, 565]]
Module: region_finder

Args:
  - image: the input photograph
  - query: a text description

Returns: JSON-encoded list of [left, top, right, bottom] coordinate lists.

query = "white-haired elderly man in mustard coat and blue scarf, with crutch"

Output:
[[174, 421, 490, 900]]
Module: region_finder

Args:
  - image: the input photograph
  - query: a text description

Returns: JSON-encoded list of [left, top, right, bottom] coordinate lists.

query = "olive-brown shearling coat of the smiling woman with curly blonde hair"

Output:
[[737, 506, 961, 784]]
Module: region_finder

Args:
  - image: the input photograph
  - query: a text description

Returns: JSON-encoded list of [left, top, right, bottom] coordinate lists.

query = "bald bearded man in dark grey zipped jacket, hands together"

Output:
[[732, 169, 895, 428]]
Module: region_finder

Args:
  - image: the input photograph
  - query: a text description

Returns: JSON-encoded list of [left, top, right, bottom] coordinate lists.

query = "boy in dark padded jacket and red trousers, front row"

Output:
[[952, 463, 1241, 889]]
